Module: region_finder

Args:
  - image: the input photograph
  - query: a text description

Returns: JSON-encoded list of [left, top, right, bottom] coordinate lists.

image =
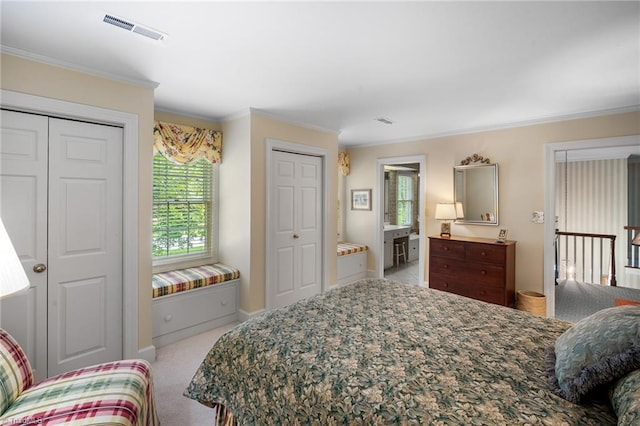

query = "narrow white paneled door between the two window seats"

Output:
[[267, 151, 323, 308]]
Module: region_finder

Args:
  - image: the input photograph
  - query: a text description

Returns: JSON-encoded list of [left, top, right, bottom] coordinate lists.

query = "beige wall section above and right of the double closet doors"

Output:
[[0, 54, 153, 349]]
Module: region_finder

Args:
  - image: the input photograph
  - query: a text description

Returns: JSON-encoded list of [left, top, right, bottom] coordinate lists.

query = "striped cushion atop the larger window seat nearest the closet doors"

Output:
[[153, 263, 240, 297]]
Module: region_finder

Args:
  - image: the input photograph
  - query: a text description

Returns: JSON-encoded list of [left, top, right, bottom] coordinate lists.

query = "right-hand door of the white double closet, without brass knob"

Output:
[[48, 118, 123, 375]]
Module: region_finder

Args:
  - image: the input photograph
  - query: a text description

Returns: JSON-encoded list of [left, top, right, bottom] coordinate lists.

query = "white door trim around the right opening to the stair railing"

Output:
[[543, 135, 640, 317]]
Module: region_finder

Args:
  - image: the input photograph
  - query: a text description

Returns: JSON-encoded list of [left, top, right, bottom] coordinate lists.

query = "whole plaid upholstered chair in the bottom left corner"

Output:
[[0, 329, 159, 426]]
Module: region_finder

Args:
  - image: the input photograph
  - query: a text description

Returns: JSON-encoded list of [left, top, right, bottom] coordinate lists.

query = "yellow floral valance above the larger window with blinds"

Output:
[[153, 121, 222, 164]]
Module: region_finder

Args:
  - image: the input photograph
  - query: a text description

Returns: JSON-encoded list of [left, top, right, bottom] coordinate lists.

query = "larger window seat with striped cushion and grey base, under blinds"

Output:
[[152, 263, 240, 347]]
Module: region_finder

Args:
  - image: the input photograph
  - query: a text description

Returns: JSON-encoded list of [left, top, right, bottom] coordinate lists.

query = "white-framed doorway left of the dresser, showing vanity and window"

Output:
[[376, 155, 426, 286]]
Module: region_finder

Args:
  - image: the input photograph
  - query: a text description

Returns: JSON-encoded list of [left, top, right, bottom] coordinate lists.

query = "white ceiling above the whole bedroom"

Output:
[[0, 0, 640, 146]]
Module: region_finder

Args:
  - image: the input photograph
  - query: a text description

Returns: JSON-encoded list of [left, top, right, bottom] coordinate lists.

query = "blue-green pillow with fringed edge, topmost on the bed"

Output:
[[547, 306, 640, 402]]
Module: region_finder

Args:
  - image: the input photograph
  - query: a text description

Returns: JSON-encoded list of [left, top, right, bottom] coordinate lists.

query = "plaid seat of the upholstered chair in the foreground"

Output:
[[0, 360, 159, 426]]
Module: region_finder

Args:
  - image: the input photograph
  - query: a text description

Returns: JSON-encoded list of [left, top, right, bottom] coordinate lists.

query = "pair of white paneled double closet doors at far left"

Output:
[[0, 110, 123, 380]]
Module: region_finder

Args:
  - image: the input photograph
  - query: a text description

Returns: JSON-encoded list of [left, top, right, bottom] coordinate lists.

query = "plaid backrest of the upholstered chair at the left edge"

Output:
[[0, 328, 33, 416]]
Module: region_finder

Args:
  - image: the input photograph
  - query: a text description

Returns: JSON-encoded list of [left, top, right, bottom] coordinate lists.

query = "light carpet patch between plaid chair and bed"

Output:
[[152, 323, 237, 426]]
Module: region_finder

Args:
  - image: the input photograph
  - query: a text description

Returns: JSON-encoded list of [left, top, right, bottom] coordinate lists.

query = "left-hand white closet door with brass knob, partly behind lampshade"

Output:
[[0, 110, 49, 380]]
